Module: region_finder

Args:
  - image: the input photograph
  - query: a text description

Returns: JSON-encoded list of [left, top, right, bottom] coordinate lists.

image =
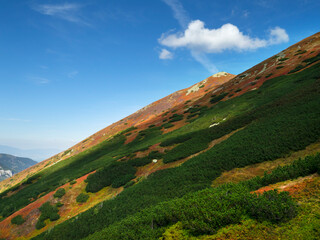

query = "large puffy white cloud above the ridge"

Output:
[[159, 20, 289, 53]]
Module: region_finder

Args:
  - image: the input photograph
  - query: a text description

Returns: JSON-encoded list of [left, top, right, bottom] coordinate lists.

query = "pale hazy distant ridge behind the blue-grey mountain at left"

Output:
[[0, 145, 61, 162]]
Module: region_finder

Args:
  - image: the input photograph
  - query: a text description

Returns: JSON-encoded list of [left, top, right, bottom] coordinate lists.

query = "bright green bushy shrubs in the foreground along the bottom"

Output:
[[83, 154, 320, 240]]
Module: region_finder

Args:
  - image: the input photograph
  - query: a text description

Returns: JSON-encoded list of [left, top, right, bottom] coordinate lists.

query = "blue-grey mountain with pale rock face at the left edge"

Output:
[[0, 153, 37, 181]]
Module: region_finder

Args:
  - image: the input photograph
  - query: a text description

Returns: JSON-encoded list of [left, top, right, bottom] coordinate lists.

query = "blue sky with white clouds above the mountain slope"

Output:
[[0, 0, 320, 156]]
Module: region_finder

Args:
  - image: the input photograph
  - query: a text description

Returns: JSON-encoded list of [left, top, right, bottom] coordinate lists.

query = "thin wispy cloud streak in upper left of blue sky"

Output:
[[33, 3, 90, 25]]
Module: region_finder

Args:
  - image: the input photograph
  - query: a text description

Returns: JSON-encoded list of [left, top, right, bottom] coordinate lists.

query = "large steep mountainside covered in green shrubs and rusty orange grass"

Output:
[[0, 33, 320, 240]]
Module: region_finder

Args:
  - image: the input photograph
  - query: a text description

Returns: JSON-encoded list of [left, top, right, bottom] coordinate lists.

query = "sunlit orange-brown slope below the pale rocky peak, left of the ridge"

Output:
[[0, 72, 234, 195]]
